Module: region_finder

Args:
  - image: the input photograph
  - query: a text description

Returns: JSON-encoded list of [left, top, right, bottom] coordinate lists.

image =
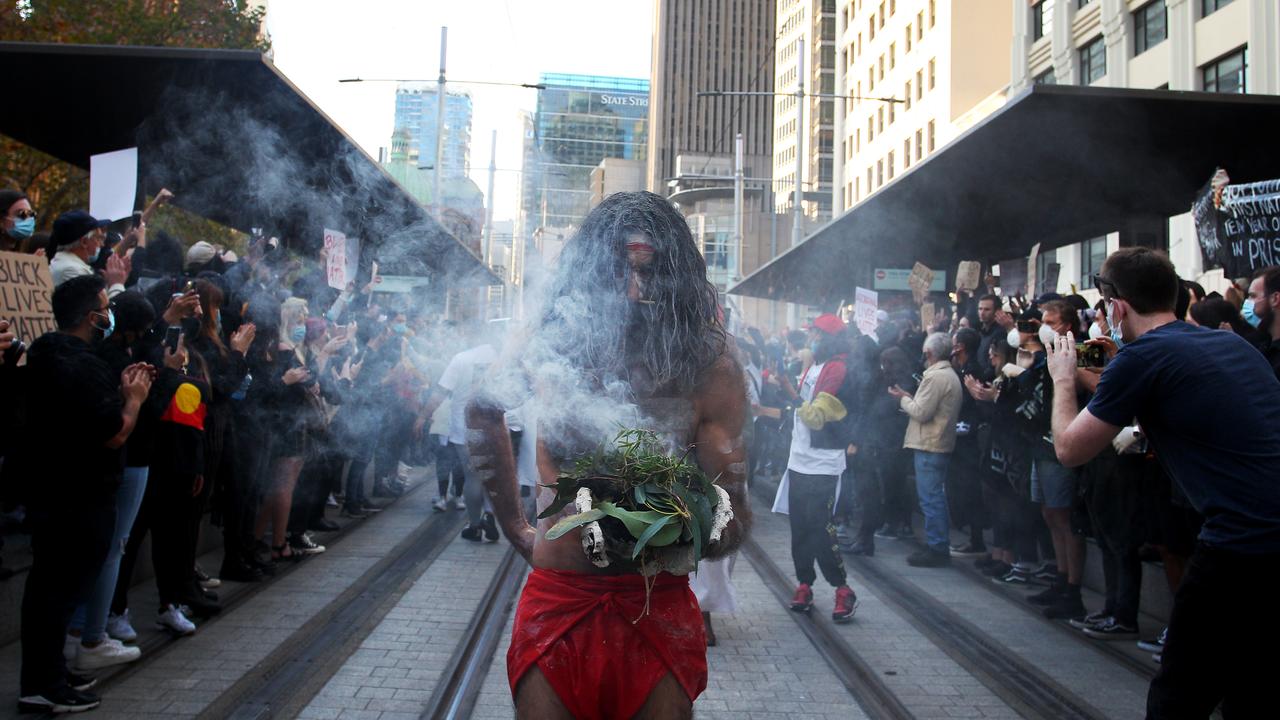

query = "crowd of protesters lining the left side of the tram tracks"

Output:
[[0, 191, 481, 712]]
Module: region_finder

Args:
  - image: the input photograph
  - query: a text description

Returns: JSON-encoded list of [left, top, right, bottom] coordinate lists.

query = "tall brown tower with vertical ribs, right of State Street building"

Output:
[[646, 0, 777, 195]]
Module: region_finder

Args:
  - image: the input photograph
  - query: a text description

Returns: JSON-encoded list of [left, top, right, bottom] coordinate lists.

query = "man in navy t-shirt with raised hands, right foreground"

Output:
[[1048, 247, 1280, 719]]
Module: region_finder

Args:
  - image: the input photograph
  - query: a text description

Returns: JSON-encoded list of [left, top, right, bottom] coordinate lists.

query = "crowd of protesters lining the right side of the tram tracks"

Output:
[[739, 254, 1280, 676]]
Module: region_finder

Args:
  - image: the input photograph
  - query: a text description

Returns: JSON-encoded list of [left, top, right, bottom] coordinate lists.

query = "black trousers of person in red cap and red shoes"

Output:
[[787, 470, 846, 588]]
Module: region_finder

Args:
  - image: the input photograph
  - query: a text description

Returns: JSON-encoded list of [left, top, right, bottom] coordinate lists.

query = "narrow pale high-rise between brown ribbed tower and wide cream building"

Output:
[[773, 0, 836, 224]]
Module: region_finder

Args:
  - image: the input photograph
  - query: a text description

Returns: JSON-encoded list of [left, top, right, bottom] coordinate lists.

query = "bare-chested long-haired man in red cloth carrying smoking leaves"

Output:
[[467, 192, 750, 720]]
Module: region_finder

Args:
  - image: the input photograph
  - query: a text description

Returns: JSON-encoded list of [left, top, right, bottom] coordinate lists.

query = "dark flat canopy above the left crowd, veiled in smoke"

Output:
[[0, 42, 502, 286]]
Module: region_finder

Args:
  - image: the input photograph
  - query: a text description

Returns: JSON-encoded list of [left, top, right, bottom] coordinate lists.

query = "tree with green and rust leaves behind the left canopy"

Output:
[[0, 0, 271, 233]]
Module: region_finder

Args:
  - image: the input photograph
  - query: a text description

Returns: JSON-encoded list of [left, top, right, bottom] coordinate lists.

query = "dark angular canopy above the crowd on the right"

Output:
[[728, 85, 1280, 305]]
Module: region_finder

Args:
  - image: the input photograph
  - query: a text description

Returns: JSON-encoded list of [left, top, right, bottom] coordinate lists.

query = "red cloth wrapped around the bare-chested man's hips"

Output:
[[507, 568, 707, 720]]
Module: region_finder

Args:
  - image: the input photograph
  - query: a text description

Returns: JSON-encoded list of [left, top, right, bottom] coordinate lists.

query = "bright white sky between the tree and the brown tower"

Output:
[[266, 0, 653, 220]]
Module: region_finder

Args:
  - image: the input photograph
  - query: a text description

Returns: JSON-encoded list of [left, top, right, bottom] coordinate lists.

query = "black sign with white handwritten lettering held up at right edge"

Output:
[[1192, 179, 1280, 278]]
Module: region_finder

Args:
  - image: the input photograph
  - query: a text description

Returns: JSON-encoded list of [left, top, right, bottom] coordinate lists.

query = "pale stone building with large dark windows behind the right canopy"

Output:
[[1010, 0, 1280, 291]]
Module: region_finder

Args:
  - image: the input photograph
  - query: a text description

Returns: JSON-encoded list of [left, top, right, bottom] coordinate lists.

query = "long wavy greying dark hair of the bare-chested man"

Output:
[[538, 192, 726, 392]]
